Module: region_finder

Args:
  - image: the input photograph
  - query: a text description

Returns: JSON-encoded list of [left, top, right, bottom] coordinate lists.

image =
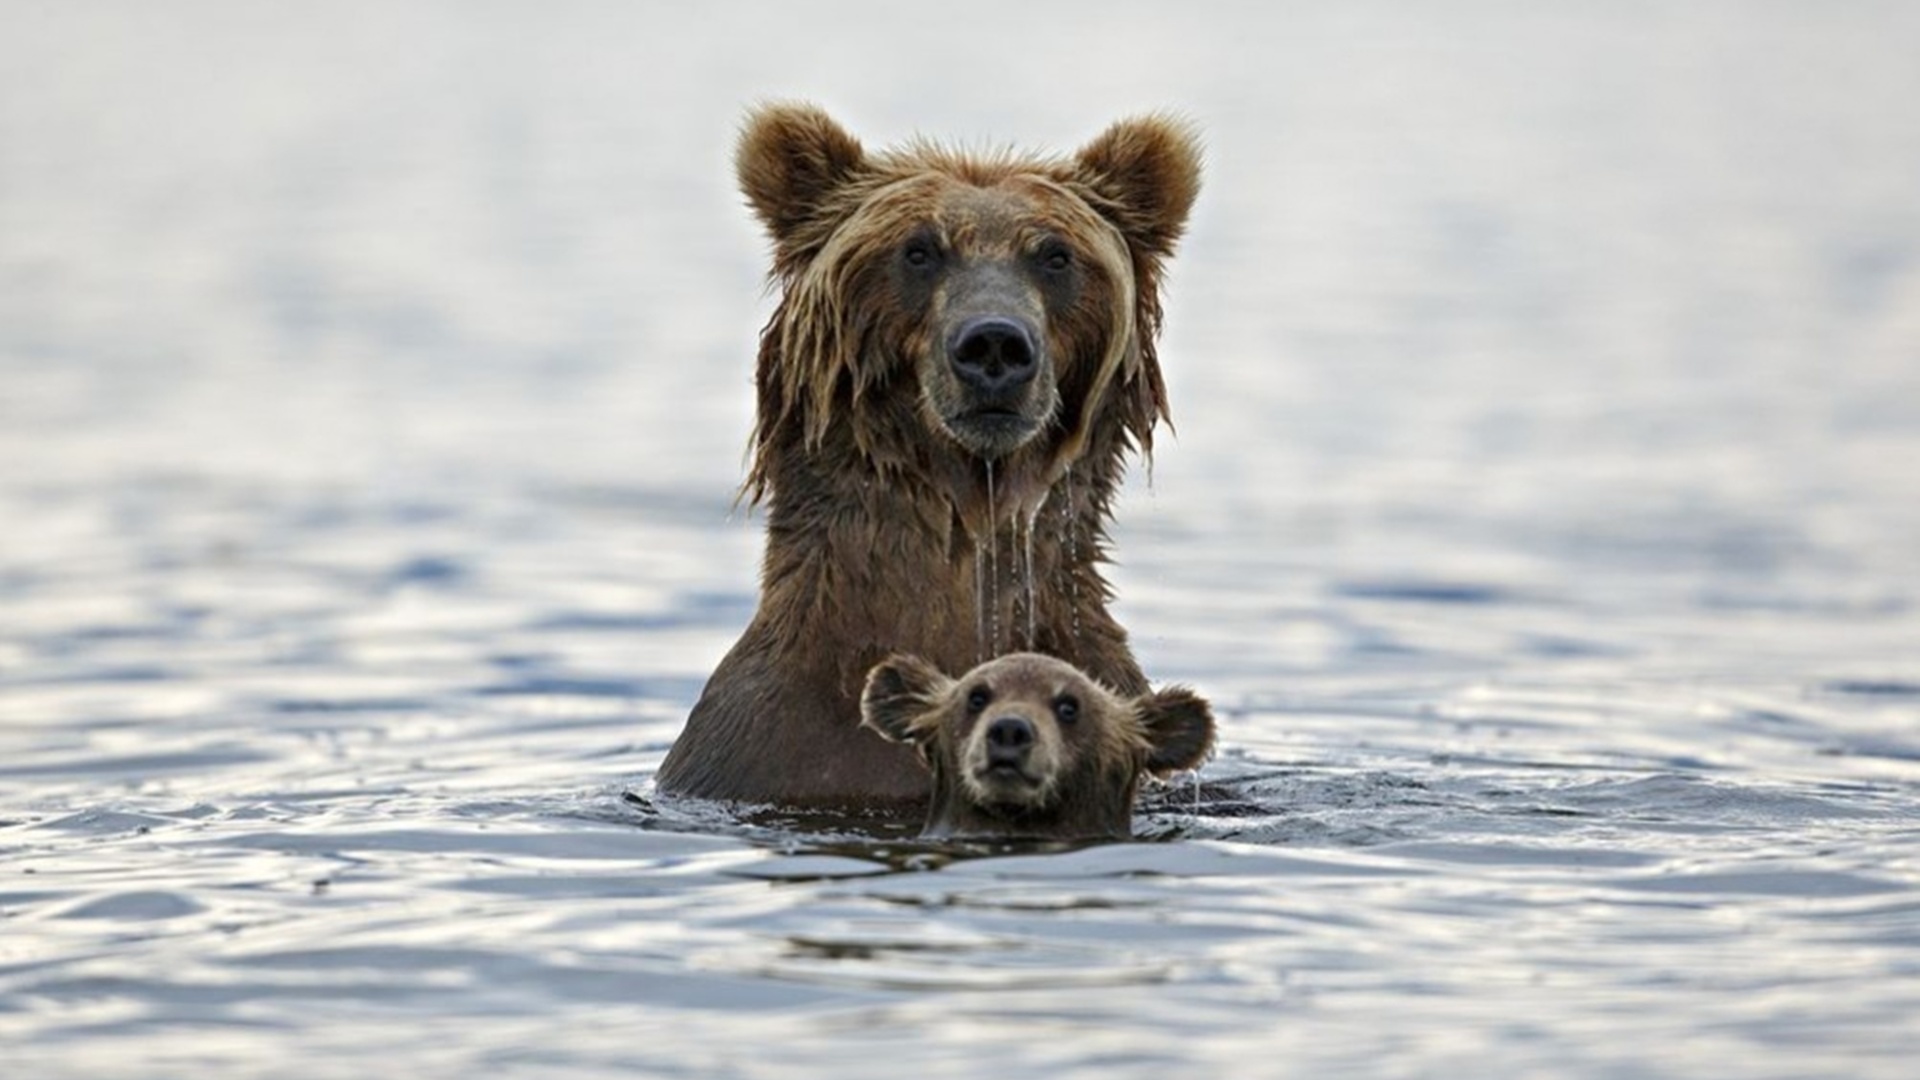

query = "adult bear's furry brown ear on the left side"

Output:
[[733, 102, 866, 244]]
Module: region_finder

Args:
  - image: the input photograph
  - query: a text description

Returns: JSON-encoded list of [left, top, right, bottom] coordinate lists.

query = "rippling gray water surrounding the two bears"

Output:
[[0, 2, 1920, 1080]]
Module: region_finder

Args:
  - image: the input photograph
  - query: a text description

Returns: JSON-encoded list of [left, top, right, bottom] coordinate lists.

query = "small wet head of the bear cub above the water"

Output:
[[860, 653, 1213, 840]]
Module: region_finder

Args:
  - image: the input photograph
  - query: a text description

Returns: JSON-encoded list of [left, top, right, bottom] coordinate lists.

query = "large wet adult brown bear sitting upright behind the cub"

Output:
[[657, 104, 1200, 813]]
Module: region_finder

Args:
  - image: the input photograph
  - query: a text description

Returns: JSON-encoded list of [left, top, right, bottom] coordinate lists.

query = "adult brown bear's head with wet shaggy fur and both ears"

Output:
[[735, 104, 1200, 498]]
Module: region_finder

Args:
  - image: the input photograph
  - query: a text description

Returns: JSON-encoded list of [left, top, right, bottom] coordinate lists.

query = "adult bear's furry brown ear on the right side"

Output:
[[1073, 113, 1200, 258]]
